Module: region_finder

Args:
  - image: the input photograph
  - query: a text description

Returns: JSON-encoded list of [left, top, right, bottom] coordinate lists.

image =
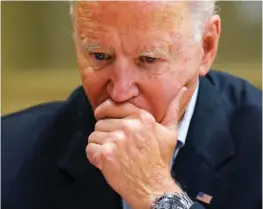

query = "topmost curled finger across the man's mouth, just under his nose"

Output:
[[94, 99, 139, 120]]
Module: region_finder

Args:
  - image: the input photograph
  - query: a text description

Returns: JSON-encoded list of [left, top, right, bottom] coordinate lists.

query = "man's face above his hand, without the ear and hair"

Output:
[[76, 2, 219, 122]]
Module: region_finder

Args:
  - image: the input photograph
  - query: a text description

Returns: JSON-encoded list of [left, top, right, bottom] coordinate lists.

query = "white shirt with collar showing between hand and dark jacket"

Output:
[[122, 82, 199, 209]]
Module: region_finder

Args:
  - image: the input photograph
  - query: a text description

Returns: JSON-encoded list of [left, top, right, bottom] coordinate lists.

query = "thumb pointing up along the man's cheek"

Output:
[[162, 86, 187, 129]]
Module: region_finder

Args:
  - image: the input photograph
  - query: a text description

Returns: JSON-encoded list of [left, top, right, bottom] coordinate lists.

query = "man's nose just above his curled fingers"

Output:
[[107, 61, 139, 102]]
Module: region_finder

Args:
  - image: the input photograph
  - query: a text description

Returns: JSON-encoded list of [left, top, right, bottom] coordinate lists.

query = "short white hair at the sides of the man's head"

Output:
[[70, 0, 217, 42]]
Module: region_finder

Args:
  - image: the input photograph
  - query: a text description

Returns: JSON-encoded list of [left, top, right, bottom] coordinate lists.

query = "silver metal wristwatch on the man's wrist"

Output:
[[152, 192, 194, 209]]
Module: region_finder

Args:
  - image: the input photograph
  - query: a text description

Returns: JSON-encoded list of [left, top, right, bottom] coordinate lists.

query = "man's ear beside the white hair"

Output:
[[199, 15, 221, 76]]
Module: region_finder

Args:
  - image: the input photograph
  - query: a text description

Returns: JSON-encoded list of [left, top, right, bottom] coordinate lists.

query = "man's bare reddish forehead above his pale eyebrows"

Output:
[[76, 1, 189, 49]]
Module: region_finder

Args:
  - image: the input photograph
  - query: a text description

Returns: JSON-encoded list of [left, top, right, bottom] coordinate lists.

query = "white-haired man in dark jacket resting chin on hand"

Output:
[[2, 1, 262, 209]]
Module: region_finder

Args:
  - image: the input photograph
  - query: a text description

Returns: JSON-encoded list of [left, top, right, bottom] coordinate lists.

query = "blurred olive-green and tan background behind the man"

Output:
[[1, 1, 262, 115]]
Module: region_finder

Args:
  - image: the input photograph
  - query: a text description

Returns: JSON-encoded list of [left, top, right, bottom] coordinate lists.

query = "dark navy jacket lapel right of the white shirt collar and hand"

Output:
[[172, 77, 234, 209]]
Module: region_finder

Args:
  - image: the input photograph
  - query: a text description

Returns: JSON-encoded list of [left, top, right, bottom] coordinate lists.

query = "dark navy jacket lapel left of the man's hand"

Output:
[[55, 132, 121, 209]]
